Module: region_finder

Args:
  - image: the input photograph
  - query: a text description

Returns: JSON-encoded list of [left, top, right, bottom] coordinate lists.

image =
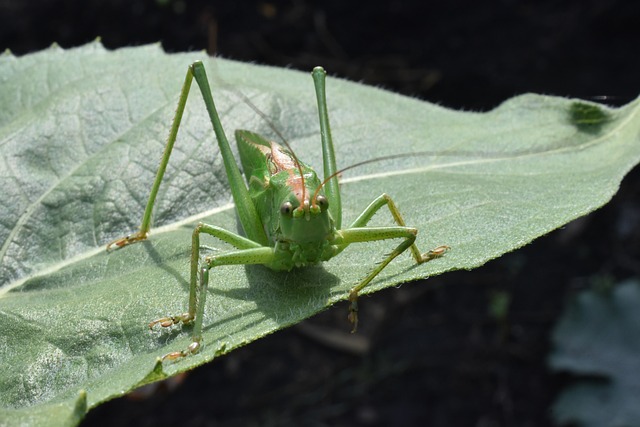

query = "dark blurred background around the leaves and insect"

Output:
[[0, 0, 640, 427]]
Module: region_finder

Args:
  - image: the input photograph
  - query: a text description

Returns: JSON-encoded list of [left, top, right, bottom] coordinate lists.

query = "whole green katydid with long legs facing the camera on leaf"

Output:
[[107, 61, 449, 359]]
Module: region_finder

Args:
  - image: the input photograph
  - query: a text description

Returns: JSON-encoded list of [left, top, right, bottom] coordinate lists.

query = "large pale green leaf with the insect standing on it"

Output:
[[0, 43, 640, 425]]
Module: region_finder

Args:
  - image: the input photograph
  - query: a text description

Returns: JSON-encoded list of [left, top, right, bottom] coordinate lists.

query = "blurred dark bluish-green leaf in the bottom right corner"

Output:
[[549, 281, 640, 427]]
